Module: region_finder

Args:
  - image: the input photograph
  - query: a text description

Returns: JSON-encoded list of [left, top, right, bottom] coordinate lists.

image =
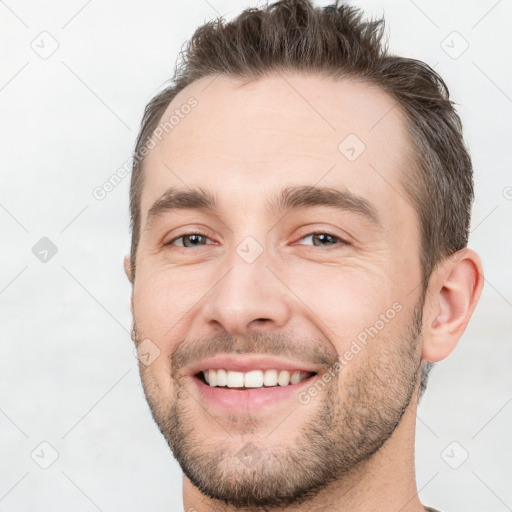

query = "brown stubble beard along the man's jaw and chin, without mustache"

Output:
[[134, 305, 422, 509]]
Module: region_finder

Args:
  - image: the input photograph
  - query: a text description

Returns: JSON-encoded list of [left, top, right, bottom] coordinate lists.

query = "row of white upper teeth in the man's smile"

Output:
[[202, 369, 310, 388]]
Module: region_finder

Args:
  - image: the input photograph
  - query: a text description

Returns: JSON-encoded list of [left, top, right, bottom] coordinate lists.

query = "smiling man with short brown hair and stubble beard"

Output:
[[125, 0, 483, 512]]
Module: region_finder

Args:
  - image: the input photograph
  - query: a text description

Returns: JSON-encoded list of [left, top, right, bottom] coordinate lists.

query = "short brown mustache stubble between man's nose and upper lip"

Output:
[[169, 332, 338, 378]]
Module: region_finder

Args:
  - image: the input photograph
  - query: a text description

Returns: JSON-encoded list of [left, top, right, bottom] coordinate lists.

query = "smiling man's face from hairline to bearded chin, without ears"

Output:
[[133, 74, 422, 506]]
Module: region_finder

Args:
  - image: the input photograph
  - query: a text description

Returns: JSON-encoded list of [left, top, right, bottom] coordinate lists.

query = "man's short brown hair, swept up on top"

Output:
[[130, 0, 473, 290]]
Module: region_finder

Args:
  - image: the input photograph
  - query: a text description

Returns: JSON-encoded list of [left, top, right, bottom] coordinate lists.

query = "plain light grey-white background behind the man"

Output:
[[0, 0, 512, 512]]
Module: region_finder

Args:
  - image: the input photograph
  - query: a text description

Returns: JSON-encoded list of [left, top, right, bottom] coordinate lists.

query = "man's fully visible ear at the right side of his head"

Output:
[[422, 248, 484, 362]]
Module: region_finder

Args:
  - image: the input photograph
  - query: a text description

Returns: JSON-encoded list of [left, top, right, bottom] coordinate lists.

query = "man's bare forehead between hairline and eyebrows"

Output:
[[141, 72, 411, 222]]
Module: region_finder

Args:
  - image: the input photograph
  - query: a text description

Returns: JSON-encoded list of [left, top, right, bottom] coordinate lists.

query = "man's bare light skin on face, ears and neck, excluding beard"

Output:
[[124, 73, 483, 512]]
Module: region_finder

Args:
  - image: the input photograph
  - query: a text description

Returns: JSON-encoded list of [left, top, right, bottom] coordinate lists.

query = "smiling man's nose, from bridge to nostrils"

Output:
[[203, 245, 291, 335]]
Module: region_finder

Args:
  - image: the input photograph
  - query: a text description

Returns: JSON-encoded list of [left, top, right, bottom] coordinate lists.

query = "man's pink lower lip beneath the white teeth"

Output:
[[192, 374, 318, 411]]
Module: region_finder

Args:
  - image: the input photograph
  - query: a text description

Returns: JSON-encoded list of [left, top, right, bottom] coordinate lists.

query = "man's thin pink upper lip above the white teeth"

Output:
[[187, 354, 318, 376]]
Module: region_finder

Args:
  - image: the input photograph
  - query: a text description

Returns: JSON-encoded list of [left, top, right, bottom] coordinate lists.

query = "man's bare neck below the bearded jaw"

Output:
[[183, 393, 425, 512]]
